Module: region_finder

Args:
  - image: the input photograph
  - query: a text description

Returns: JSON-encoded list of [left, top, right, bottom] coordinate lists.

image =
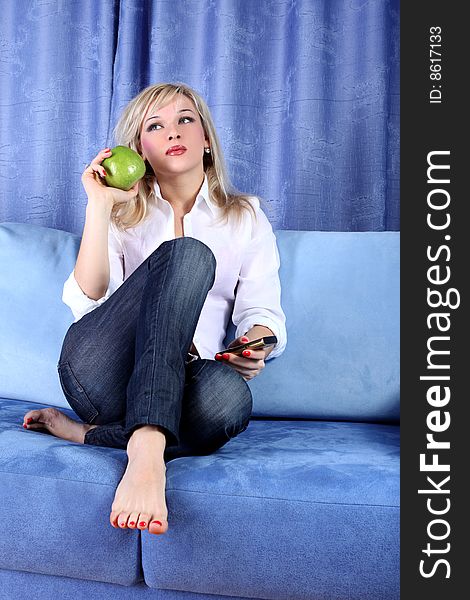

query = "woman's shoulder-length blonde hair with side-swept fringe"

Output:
[[111, 83, 255, 230]]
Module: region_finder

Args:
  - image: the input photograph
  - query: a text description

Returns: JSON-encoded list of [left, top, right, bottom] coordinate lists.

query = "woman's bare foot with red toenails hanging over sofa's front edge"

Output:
[[109, 425, 168, 535]]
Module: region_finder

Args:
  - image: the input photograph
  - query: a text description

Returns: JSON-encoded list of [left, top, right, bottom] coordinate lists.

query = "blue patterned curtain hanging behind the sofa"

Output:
[[0, 0, 399, 234]]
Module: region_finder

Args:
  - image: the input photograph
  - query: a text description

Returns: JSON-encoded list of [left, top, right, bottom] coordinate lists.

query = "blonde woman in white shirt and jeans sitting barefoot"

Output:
[[23, 84, 286, 534]]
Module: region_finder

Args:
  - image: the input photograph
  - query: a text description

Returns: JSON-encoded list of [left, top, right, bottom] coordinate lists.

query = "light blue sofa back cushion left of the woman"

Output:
[[0, 223, 75, 407]]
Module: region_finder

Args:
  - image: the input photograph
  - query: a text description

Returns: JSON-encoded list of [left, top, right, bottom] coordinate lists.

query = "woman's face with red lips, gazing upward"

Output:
[[140, 94, 209, 177]]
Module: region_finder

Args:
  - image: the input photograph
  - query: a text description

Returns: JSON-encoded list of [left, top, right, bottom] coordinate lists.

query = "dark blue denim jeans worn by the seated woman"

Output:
[[58, 237, 252, 460]]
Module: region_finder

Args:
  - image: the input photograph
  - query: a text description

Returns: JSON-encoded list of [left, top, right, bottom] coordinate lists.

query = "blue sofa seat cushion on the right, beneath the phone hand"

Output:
[[142, 419, 399, 600]]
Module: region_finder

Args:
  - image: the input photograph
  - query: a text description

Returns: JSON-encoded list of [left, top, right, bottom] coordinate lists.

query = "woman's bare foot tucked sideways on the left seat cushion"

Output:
[[23, 408, 97, 444]]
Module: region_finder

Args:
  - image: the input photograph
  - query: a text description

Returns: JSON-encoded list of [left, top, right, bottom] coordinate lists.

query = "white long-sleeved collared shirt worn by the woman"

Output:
[[62, 178, 287, 359]]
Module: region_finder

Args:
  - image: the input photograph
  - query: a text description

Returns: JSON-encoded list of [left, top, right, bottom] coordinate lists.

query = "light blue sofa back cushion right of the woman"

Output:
[[250, 231, 400, 422]]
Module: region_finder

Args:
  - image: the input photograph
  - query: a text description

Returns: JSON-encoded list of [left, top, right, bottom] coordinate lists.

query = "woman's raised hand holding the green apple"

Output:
[[82, 148, 139, 209]]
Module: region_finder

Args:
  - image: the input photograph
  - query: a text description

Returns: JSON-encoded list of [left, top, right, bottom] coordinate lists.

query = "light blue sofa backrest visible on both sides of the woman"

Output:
[[0, 223, 399, 421]]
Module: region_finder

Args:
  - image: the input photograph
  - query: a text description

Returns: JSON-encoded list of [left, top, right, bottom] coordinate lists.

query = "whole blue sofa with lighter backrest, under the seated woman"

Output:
[[0, 223, 399, 600]]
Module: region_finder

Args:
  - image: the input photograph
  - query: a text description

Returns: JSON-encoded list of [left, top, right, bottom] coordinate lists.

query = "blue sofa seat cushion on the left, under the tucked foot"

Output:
[[0, 398, 142, 585]]
